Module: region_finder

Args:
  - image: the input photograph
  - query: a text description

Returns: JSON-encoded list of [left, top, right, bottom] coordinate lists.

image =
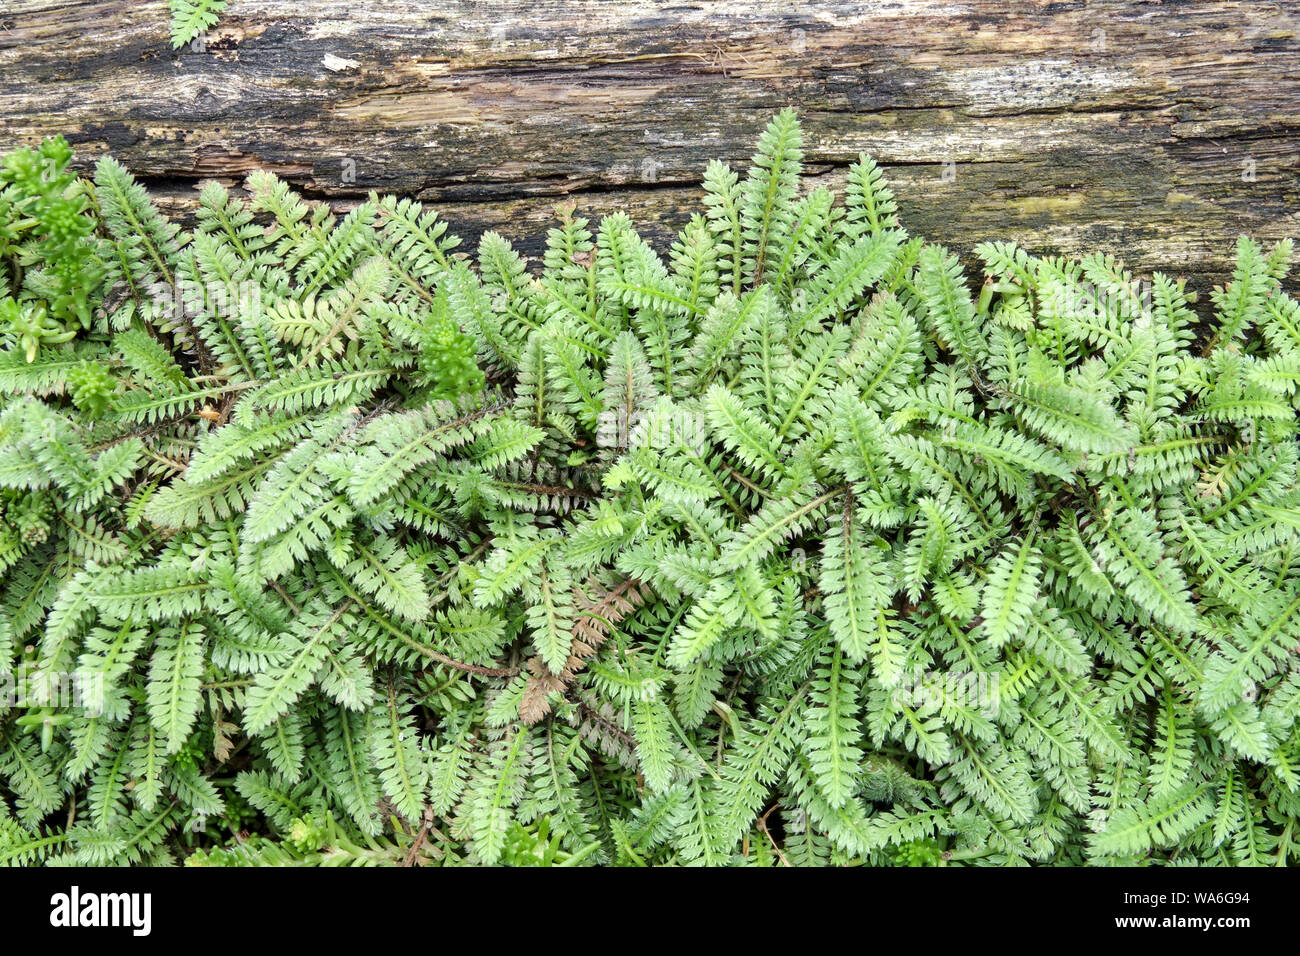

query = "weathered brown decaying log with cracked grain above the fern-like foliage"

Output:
[[0, 0, 1300, 287]]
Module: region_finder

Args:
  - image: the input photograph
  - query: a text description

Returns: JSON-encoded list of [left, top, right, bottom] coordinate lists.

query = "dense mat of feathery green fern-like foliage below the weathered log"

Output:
[[0, 111, 1300, 865]]
